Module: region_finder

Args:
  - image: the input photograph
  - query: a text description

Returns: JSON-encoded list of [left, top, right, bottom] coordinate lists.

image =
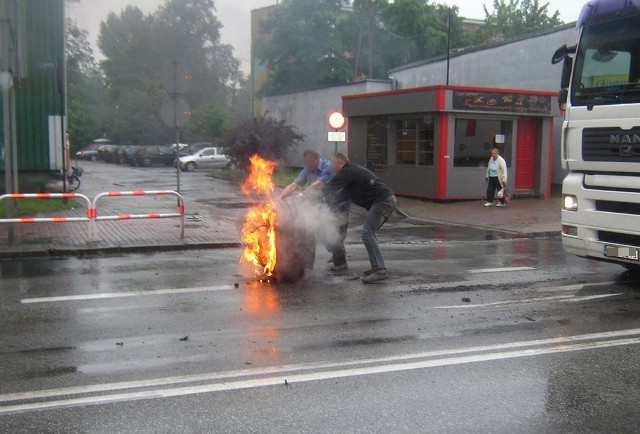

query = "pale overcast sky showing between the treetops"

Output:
[[67, 0, 586, 72]]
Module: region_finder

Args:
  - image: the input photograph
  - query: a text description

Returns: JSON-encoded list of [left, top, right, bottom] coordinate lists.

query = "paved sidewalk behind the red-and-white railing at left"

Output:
[[0, 198, 240, 257]]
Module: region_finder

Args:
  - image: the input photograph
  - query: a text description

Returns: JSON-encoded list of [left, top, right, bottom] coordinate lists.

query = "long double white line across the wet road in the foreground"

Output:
[[0, 329, 640, 414]]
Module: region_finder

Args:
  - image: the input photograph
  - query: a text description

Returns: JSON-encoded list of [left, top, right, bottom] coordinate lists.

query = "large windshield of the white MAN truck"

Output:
[[571, 17, 640, 106]]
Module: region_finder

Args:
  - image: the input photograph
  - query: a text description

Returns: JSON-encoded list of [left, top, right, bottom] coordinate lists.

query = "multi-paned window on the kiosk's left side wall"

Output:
[[394, 115, 435, 166]]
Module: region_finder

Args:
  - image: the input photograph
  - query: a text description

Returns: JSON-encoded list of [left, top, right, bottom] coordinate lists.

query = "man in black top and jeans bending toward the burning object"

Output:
[[325, 153, 396, 283]]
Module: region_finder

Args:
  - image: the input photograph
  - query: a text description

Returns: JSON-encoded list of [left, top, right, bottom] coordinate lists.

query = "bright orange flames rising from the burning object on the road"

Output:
[[241, 155, 277, 276]]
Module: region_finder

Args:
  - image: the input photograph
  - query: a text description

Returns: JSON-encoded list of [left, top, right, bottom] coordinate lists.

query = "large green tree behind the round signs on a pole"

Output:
[[98, 0, 243, 144]]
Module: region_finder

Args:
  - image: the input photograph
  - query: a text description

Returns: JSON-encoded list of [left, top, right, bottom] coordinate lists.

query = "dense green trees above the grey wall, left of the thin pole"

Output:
[[257, 0, 470, 93]]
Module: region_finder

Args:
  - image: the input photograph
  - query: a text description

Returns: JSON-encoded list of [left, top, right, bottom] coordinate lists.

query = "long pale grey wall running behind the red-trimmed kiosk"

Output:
[[262, 24, 578, 184]]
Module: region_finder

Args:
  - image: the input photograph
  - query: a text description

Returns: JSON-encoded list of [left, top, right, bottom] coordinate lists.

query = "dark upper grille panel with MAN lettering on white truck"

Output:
[[582, 127, 640, 163]]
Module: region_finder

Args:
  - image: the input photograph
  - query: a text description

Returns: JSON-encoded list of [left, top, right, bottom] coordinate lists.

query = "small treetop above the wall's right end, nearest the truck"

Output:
[[476, 0, 563, 43]]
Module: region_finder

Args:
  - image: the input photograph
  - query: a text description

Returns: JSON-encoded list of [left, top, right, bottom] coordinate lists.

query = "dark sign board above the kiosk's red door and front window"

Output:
[[453, 90, 551, 114]]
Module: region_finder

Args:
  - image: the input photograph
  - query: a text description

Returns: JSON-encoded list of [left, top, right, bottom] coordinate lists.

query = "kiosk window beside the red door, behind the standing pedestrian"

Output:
[[453, 119, 513, 167]]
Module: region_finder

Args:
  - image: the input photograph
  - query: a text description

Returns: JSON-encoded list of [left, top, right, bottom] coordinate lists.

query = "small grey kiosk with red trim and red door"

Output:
[[343, 86, 560, 200]]
